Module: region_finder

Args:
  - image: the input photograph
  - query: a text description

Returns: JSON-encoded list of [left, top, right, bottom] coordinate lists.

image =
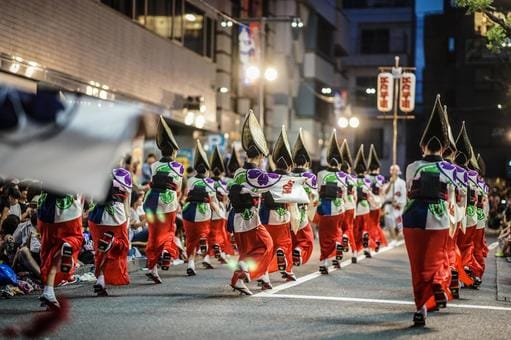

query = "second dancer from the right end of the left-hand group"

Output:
[[353, 144, 371, 258]]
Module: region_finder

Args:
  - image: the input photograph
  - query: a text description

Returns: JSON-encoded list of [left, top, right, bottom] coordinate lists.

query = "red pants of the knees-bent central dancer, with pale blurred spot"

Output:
[[234, 225, 273, 280]]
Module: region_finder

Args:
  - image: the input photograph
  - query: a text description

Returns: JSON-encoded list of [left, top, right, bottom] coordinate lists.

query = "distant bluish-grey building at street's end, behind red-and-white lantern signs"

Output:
[[342, 0, 414, 175]]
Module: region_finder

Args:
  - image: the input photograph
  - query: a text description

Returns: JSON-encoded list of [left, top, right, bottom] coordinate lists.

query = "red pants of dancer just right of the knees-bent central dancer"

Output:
[[264, 223, 293, 273]]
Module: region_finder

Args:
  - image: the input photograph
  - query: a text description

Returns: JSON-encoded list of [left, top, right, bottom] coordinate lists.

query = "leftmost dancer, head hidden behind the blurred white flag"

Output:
[[37, 191, 83, 310]]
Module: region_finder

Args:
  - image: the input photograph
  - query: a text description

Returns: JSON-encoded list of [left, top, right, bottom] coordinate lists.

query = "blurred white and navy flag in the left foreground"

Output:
[[0, 84, 143, 199]]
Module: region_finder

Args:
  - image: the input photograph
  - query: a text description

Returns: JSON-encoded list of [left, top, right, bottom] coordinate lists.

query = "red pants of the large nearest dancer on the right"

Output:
[[403, 227, 451, 309]]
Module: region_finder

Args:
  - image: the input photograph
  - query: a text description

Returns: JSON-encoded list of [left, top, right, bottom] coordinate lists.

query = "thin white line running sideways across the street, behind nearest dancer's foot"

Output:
[[254, 292, 511, 311]]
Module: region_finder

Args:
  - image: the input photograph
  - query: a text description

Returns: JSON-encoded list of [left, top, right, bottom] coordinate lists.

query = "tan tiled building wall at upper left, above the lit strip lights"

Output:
[[0, 0, 217, 129]]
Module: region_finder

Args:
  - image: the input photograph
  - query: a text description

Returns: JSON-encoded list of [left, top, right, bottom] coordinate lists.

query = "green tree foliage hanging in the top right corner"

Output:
[[455, 0, 511, 52]]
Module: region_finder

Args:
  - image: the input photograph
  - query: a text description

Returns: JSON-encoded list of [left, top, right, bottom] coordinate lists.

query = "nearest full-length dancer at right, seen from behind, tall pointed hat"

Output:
[[403, 96, 456, 326]]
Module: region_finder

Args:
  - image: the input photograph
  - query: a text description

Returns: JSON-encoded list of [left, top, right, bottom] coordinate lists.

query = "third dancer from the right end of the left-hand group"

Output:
[[341, 138, 358, 263]]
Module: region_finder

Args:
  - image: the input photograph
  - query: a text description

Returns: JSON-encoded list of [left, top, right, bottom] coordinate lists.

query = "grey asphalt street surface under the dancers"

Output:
[[0, 238, 511, 339]]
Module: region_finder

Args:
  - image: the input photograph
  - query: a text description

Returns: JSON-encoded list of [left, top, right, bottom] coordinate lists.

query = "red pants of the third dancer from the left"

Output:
[[145, 211, 179, 269]]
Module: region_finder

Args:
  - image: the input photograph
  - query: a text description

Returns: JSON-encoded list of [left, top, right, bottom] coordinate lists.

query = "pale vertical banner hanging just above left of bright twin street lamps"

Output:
[[238, 23, 259, 84]]
